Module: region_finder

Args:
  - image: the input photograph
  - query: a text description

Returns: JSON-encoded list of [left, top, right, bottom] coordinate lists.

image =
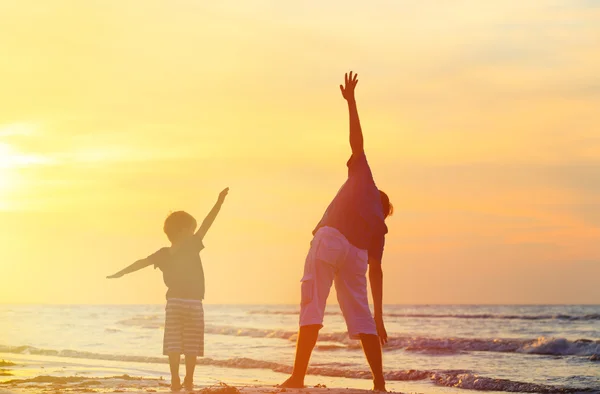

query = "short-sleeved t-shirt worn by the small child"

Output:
[[148, 237, 204, 300]]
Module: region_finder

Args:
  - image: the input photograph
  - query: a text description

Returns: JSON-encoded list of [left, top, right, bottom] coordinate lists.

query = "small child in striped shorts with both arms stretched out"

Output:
[[107, 188, 229, 391]]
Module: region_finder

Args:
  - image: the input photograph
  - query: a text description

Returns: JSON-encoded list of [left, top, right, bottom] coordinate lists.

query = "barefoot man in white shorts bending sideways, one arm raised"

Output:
[[282, 72, 393, 391]]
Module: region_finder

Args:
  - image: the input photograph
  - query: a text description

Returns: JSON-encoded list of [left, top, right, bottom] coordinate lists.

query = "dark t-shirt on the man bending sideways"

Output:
[[313, 152, 388, 261]]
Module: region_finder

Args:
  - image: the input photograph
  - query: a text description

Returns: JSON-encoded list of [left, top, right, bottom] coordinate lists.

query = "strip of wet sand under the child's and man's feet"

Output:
[[0, 354, 556, 394]]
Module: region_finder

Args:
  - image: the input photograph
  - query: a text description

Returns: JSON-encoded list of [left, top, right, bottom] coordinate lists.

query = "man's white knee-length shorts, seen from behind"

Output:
[[300, 227, 377, 339]]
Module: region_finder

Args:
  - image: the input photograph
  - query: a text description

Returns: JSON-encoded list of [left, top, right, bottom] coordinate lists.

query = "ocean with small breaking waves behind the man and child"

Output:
[[0, 304, 600, 393]]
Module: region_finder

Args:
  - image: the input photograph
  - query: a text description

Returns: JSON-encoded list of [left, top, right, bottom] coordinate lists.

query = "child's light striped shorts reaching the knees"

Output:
[[163, 298, 204, 356]]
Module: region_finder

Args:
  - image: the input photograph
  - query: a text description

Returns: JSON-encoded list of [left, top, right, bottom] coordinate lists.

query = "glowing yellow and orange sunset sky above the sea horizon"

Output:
[[0, 0, 600, 304]]
